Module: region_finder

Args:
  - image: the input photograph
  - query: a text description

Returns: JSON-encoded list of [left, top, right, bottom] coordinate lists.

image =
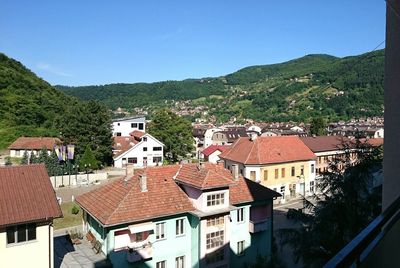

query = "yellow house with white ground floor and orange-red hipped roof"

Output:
[[219, 136, 317, 203]]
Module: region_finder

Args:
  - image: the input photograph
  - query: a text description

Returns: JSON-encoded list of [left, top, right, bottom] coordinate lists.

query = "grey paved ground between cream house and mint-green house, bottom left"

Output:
[[54, 235, 112, 268]]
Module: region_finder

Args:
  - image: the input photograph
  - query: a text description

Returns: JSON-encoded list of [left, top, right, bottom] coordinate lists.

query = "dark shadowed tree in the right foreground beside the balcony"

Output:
[[280, 142, 383, 267]]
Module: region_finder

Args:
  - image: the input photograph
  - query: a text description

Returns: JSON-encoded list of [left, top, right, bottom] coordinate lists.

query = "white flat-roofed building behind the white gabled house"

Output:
[[112, 115, 146, 137]]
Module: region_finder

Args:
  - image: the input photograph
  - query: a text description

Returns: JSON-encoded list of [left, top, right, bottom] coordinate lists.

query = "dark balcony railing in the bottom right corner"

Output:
[[324, 197, 400, 268]]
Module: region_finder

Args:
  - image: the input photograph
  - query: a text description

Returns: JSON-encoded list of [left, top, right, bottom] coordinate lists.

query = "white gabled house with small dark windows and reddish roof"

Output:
[[113, 130, 164, 168]]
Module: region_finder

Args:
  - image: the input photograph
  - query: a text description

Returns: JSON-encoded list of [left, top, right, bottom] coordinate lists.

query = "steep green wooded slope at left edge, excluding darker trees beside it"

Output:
[[0, 53, 77, 148]]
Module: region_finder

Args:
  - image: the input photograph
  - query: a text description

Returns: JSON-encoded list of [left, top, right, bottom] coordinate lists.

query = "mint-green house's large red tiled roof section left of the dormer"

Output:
[[76, 165, 195, 226]]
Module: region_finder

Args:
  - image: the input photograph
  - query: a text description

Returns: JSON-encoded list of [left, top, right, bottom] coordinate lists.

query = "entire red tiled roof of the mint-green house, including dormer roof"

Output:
[[76, 163, 280, 226]]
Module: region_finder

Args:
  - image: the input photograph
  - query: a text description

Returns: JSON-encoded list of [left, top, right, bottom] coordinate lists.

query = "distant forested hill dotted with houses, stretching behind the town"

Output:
[[57, 50, 384, 122]]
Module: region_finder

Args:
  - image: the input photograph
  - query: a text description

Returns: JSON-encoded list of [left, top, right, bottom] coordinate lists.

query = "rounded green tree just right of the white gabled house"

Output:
[[148, 109, 194, 162]]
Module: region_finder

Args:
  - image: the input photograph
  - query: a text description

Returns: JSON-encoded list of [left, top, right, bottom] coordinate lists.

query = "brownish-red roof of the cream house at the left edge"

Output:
[[0, 165, 62, 226]]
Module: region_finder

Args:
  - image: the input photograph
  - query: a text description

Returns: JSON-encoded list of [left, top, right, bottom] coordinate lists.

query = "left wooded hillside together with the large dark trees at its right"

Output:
[[0, 53, 112, 164]]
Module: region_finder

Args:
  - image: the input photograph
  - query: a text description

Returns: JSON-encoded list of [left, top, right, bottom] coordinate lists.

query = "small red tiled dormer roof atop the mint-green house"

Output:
[[176, 163, 233, 190]]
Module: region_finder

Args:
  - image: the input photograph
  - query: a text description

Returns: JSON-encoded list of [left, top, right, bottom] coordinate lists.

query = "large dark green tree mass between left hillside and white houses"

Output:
[[57, 101, 113, 164]]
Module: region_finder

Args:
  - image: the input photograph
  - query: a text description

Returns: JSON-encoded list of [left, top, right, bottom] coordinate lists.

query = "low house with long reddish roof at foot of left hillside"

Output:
[[8, 137, 61, 158]]
